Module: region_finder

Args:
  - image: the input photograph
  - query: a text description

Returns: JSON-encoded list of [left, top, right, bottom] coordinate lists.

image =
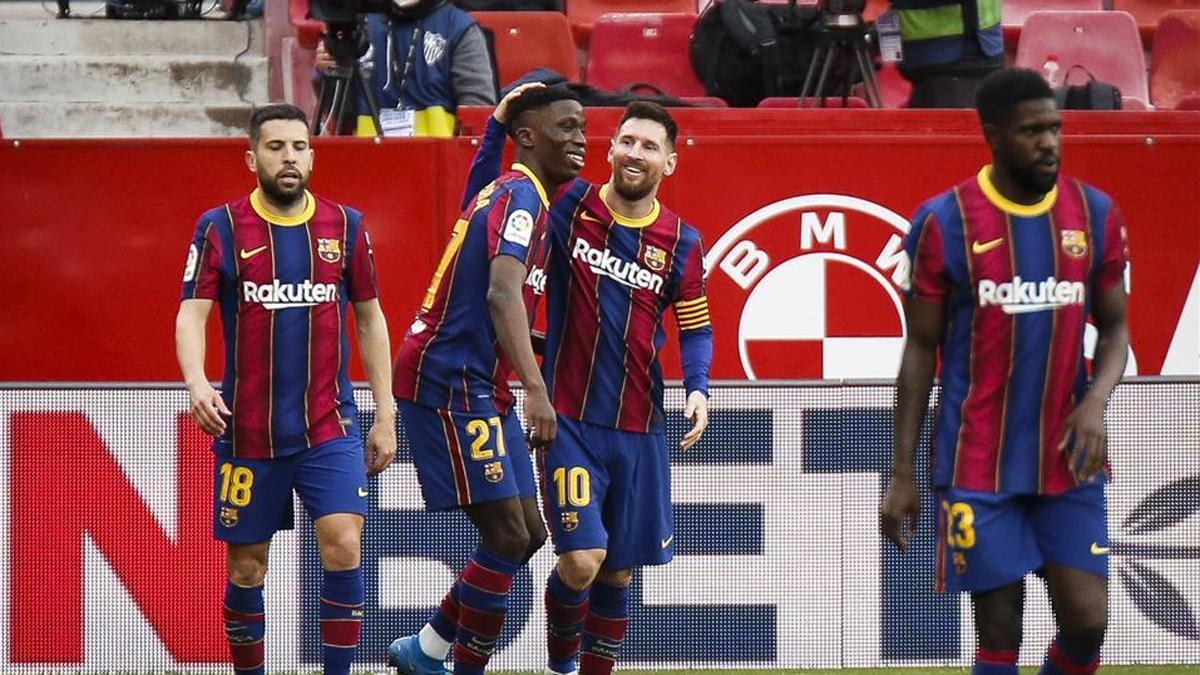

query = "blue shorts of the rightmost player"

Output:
[[937, 479, 1109, 592]]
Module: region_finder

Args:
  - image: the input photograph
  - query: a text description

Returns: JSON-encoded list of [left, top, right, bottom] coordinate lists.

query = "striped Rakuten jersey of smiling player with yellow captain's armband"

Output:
[[542, 179, 712, 432]]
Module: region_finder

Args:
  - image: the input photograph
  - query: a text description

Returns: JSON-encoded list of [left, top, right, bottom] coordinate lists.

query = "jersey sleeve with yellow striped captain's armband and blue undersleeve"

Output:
[[672, 238, 713, 395]]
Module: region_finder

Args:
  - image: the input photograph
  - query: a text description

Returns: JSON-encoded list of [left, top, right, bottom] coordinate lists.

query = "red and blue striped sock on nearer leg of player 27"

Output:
[[454, 546, 521, 675]]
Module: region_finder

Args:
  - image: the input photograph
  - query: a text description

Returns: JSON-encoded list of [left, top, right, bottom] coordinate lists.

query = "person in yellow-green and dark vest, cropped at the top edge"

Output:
[[892, 0, 1004, 108]]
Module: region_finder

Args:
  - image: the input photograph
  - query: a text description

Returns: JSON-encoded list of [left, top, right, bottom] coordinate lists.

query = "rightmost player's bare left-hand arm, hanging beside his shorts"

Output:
[[880, 298, 946, 551]]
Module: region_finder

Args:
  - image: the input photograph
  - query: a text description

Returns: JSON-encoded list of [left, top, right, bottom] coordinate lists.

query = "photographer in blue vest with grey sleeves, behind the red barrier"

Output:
[[317, 0, 496, 136]]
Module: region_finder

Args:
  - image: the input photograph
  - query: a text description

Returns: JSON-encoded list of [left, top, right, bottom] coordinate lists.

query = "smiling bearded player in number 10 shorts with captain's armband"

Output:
[[470, 102, 713, 675]]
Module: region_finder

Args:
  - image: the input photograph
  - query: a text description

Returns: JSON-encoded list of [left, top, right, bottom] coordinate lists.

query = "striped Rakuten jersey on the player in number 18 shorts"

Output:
[[182, 190, 379, 459]]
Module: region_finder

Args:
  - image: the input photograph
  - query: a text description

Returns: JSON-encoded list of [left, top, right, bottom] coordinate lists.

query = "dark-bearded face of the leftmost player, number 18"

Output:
[[246, 120, 312, 207]]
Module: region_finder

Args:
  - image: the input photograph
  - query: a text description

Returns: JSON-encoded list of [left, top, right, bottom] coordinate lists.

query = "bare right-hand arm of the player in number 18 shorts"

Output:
[[354, 298, 396, 476]]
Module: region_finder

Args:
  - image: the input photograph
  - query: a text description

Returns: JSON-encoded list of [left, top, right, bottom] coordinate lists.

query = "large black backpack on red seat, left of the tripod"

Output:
[[690, 0, 821, 107]]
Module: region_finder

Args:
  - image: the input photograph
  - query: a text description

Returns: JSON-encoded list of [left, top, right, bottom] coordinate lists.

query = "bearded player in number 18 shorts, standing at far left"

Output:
[[175, 104, 396, 675]]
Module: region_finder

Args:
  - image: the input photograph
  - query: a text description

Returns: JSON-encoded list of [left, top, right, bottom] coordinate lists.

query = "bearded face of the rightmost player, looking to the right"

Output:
[[991, 98, 1062, 195]]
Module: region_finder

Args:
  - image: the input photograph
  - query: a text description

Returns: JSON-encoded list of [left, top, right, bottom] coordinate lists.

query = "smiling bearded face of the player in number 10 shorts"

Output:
[[608, 118, 676, 202]]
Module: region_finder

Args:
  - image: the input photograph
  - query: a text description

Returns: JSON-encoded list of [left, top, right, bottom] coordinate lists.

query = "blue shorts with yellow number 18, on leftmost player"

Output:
[[212, 434, 367, 544]]
